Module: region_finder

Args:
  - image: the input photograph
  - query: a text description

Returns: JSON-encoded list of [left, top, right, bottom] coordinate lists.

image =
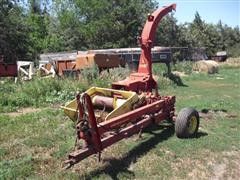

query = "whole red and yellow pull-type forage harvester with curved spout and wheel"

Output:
[[63, 4, 199, 167]]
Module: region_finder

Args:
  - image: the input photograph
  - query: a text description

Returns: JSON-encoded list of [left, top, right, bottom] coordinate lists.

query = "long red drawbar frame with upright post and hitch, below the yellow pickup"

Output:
[[65, 94, 175, 167]]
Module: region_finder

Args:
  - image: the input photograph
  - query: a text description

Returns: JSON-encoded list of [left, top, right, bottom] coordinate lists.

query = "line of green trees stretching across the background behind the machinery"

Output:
[[0, 0, 240, 61]]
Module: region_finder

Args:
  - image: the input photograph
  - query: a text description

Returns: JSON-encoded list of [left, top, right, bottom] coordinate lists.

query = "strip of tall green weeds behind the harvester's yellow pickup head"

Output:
[[0, 67, 130, 113]]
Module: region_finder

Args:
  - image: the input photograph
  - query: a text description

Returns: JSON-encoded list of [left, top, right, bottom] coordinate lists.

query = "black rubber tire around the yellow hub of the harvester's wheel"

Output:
[[175, 107, 199, 138]]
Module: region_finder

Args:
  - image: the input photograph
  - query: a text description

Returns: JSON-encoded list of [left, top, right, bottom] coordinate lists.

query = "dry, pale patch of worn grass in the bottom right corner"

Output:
[[171, 150, 240, 180]]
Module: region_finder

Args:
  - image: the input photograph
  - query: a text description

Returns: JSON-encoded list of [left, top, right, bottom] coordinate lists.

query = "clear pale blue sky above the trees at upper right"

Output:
[[157, 0, 240, 27]]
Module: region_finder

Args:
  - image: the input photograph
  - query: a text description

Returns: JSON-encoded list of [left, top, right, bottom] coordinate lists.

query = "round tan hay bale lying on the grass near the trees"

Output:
[[193, 60, 218, 74]]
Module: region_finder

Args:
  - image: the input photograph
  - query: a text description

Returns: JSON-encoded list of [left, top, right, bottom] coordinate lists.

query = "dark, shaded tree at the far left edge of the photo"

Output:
[[0, 0, 28, 62]]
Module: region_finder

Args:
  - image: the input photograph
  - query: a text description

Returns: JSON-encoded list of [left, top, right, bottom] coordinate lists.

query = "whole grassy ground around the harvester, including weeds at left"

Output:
[[0, 61, 240, 179]]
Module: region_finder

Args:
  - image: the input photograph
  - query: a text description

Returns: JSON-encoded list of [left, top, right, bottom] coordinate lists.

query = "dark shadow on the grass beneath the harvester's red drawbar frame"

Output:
[[87, 125, 174, 179]]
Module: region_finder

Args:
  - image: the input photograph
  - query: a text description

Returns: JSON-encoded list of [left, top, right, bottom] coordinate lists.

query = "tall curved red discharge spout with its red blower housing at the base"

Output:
[[112, 4, 176, 92]]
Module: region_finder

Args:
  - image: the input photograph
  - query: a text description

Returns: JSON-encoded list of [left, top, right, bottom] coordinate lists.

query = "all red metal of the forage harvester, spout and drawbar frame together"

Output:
[[65, 4, 176, 166]]
